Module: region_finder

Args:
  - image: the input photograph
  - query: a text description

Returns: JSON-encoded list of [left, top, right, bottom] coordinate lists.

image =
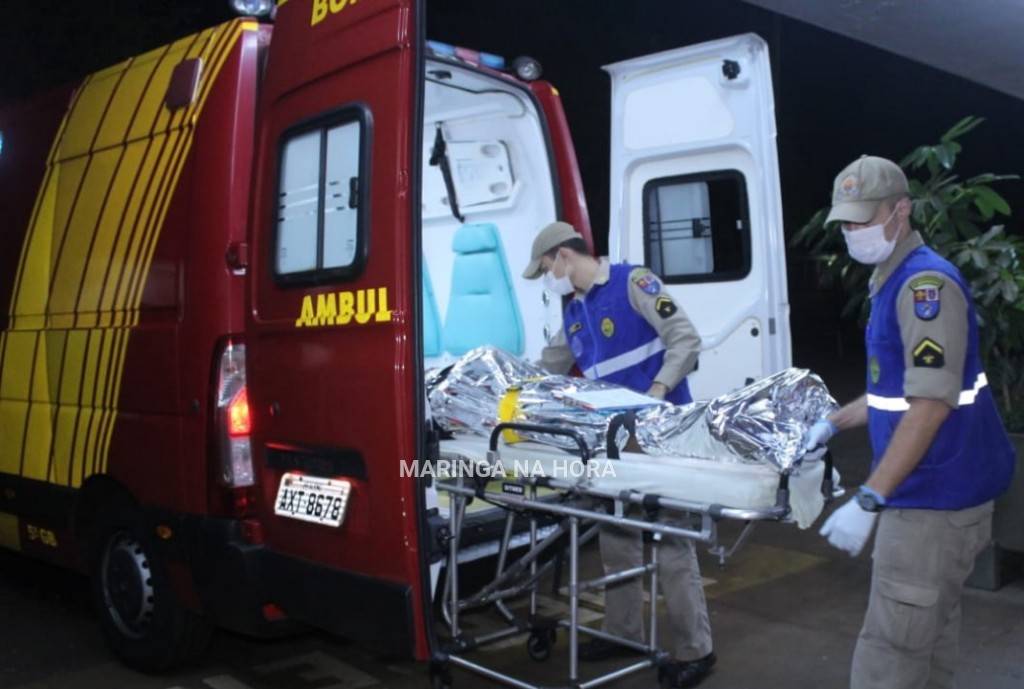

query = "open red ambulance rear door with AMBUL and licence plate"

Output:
[[245, 0, 429, 658]]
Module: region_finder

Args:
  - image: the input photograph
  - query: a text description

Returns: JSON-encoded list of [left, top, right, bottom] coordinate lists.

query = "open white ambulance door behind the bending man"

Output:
[[604, 34, 792, 399]]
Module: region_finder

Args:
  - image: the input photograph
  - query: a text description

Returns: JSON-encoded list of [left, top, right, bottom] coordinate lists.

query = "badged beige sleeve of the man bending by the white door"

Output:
[[628, 268, 700, 390]]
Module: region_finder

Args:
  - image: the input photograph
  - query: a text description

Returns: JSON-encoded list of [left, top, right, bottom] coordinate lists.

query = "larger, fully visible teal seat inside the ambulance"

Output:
[[441, 222, 524, 355]]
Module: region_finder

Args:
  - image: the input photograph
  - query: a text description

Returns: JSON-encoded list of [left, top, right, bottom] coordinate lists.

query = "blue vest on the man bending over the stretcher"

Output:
[[563, 263, 692, 404]]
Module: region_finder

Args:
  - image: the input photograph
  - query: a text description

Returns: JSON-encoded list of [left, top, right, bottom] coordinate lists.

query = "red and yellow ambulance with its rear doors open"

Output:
[[0, 0, 791, 672]]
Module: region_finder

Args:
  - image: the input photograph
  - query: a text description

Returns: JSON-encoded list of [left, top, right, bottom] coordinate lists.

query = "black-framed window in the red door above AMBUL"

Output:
[[274, 109, 366, 282]]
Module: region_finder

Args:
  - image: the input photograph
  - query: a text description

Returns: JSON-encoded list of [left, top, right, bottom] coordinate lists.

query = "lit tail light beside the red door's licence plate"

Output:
[[214, 342, 255, 487]]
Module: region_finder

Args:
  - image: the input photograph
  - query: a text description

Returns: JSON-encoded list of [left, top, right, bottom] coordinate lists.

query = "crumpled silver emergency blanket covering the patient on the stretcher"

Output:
[[427, 347, 838, 473]]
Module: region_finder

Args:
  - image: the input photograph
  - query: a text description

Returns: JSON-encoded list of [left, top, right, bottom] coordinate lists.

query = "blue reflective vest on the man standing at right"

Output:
[[865, 246, 1015, 510]]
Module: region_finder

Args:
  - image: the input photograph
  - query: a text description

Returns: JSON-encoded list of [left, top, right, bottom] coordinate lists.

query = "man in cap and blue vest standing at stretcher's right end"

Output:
[[807, 156, 1014, 689]]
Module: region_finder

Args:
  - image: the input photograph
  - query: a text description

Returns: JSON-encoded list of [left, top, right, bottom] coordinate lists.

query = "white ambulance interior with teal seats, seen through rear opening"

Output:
[[421, 60, 560, 369]]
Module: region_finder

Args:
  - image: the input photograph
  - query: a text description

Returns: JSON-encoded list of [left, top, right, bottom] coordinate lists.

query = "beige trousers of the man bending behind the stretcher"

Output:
[[600, 508, 712, 660]]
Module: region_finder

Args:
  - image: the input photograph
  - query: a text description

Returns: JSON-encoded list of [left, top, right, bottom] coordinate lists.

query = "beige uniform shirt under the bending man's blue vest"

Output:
[[537, 258, 700, 392]]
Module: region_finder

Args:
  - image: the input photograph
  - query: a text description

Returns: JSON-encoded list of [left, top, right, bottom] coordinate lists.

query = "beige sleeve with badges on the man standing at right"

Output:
[[896, 271, 969, 410]]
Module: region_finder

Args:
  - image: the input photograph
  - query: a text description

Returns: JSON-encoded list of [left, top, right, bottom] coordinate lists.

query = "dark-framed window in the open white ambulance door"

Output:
[[643, 170, 751, 284]]
